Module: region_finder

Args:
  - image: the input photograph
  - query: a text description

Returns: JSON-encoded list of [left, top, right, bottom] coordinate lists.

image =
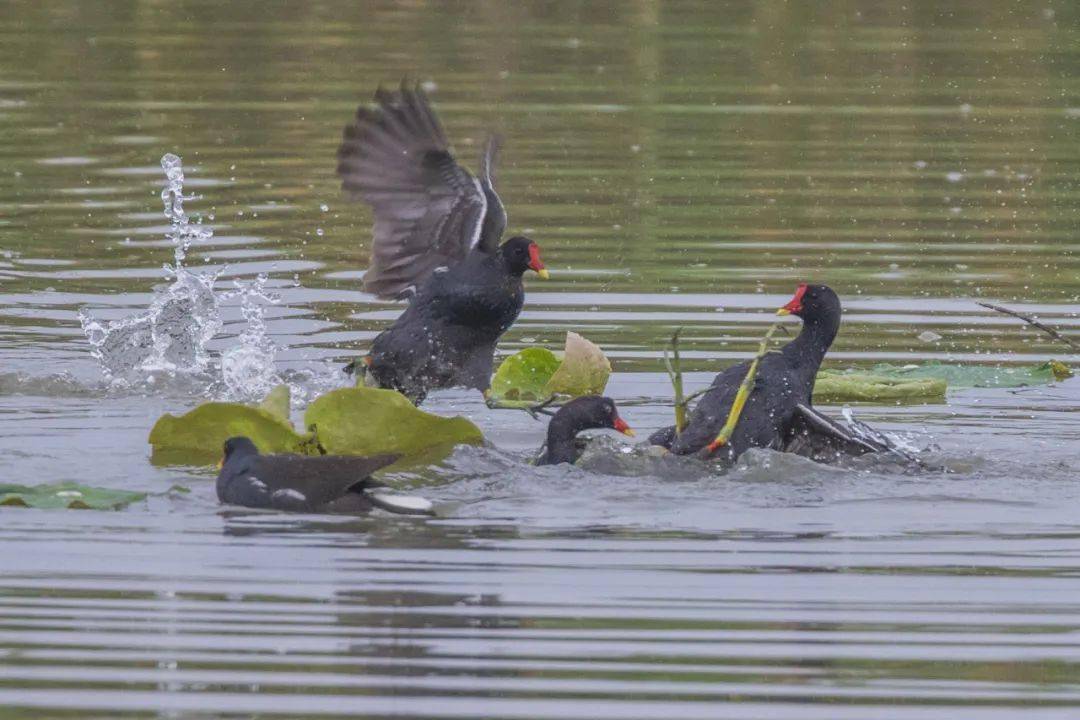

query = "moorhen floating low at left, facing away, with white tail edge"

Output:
[[217, 437, 432, 515]]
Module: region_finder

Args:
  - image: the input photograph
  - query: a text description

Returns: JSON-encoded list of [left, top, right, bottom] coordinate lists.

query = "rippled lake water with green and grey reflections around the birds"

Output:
[[0, 0, 1080, 720]]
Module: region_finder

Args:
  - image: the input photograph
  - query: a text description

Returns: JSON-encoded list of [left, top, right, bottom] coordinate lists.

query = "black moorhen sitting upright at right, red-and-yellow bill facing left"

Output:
[[649, 284, 840, 462]]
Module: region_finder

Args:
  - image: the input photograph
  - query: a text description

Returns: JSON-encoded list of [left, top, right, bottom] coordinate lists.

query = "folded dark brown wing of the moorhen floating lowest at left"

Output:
[[254, 454, 397, 507]]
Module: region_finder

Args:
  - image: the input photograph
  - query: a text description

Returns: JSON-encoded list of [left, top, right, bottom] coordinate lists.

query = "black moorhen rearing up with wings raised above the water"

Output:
[[337, 83, 548, 405]]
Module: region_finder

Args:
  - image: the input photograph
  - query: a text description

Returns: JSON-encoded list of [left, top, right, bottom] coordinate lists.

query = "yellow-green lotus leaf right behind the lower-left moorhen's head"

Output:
[[149, 403, 318, 465]]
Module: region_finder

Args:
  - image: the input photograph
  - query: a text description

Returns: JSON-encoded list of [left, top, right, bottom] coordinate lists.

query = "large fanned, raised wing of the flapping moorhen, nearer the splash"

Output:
[[337, 83, 494, 298]]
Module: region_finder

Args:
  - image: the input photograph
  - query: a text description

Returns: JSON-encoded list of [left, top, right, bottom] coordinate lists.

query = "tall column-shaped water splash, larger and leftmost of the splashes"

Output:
[[79, 153, 221, 383]]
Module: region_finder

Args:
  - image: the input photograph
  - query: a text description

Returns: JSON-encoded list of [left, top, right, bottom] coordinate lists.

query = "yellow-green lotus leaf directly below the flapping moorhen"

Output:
[[303, 388, 484, 459]]
